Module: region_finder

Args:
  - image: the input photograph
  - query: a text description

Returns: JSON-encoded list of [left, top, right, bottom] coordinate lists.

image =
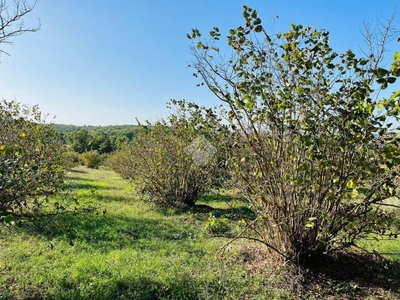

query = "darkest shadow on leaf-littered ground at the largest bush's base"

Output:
[[305, 252, 400, 299]]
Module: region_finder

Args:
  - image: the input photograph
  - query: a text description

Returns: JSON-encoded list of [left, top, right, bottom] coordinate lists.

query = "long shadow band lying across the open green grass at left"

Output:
[[18, 213, 198, 251]]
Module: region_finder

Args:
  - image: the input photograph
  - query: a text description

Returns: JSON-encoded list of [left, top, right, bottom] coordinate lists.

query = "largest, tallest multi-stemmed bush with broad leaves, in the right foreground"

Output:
[[188, 6, 400, 262]]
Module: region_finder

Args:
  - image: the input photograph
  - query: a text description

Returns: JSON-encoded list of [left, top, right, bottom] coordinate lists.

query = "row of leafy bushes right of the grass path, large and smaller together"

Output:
[[108, 6, 400, 263]]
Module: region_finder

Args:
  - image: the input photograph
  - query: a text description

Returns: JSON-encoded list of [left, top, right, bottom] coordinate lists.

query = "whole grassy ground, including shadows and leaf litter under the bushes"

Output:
[[0, 167, 400, 299]]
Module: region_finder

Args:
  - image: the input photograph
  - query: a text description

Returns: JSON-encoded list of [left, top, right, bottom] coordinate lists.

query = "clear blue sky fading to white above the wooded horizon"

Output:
[[0, 0, 400, 125]]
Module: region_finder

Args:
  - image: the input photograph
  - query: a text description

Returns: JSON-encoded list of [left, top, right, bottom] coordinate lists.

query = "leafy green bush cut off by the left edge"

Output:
[[0, 100, 64, 216]]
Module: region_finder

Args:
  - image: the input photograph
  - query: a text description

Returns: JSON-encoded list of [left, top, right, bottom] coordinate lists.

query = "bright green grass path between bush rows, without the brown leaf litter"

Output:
[[0, 167, 276, 299]]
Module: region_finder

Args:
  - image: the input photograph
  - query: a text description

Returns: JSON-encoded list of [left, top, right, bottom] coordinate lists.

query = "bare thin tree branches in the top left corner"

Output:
[[0, 0, 40, 55]]
